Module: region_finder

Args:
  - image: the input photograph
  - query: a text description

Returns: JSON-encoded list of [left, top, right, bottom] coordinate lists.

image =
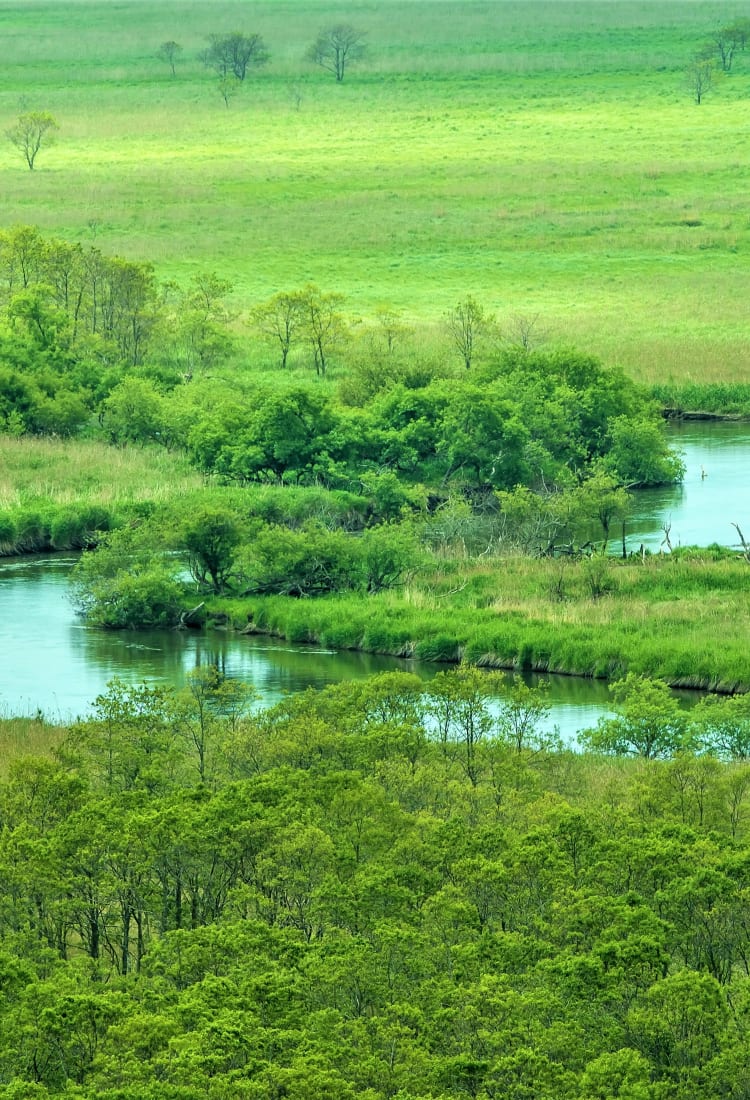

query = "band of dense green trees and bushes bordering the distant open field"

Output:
[[0, 227, 681, 490]]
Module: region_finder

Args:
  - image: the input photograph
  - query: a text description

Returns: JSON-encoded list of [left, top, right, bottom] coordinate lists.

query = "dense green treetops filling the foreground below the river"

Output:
[[0, 669, 750, 1100]]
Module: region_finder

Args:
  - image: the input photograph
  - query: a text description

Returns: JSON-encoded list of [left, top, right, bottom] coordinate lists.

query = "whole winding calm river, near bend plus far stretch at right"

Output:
[[0, 424, 750, 739]]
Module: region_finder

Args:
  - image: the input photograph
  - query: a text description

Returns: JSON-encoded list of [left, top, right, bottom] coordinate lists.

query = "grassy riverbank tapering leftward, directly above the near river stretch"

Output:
[[214, 551, 750, 691]]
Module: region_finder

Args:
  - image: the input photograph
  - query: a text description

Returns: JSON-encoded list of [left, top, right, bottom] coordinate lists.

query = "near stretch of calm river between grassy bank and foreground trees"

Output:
[[0, 556, 607, 739]]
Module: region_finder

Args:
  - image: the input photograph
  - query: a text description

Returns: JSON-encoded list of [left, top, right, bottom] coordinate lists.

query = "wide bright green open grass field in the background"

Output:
[[0, 0, 750, 382]]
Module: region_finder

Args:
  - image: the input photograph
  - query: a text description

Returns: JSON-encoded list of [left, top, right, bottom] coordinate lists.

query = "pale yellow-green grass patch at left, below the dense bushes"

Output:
[[0, 436, 202, 509]]
